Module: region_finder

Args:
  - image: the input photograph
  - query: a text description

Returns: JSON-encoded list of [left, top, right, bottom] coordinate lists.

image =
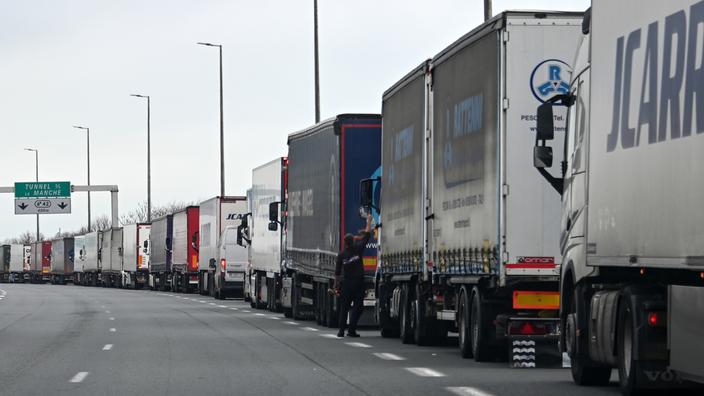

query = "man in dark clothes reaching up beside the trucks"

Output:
[[335, 214, 372, 337]]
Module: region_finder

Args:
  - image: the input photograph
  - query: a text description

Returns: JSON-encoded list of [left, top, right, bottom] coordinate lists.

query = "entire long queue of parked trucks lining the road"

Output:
[[2, 0, 704, 395]]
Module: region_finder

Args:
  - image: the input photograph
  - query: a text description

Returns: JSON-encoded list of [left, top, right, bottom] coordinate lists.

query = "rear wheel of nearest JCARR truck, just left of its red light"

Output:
[[620, 296, 639, 396]]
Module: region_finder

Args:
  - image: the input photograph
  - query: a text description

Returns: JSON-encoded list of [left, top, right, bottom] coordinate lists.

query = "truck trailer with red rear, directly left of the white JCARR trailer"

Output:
[[171, 206, 200, 293]]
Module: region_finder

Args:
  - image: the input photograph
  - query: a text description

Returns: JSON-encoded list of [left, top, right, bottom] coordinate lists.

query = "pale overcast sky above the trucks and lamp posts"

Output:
[[0, 0, 589, 241]]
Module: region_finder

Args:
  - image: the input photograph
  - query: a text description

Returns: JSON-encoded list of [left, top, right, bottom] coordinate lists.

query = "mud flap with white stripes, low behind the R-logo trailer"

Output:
[[508, 336, 563, 368]]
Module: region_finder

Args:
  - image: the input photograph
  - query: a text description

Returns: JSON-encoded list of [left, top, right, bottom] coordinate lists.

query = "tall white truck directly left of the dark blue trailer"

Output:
[[246, 157, 288, 311]]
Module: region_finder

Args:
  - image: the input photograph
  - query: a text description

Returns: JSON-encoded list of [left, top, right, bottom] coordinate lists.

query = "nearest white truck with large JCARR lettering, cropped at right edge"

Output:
[[534, 0, 704, 395]]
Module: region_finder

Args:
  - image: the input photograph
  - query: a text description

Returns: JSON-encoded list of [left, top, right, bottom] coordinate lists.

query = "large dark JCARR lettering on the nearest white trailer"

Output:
[[606, 1, 704, 153]]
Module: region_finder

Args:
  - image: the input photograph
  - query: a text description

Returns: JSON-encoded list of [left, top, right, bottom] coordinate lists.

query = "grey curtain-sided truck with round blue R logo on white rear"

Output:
[[362, 11, 582, 367]]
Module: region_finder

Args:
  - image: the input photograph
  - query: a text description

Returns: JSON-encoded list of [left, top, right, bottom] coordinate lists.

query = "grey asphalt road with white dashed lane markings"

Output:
[[0, 284, 619, 396]]
